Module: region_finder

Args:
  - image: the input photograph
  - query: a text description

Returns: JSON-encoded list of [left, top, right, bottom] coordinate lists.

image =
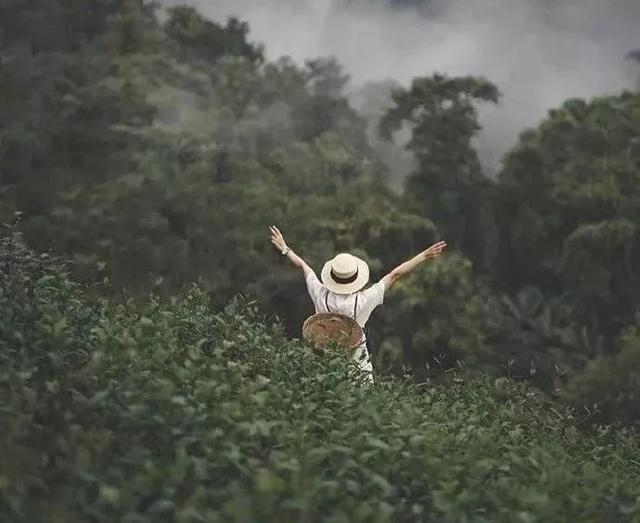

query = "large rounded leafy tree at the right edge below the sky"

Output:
[[496, 93, 640, 340]]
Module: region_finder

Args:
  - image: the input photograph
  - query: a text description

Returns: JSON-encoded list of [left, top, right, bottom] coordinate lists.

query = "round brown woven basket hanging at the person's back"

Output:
[[302, 312, 363, 350]]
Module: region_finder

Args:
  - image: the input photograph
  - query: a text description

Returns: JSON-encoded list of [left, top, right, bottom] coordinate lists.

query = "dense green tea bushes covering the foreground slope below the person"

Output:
[[0, 235, 640, 523]]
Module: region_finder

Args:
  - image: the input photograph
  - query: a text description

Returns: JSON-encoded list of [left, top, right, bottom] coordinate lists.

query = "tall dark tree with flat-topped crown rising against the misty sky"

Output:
[[380, 75, 499, 267]]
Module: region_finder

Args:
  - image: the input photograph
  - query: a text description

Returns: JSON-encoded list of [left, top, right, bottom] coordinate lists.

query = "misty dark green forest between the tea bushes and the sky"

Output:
[[0, 0, 640, 424]]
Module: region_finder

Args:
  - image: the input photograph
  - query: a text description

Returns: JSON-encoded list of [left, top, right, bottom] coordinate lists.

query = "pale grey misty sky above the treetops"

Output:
[[158, 0, 640, 172]]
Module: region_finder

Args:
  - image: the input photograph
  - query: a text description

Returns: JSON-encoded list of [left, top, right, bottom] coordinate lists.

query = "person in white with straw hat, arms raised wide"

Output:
[[269, 225, 447, 382]]
